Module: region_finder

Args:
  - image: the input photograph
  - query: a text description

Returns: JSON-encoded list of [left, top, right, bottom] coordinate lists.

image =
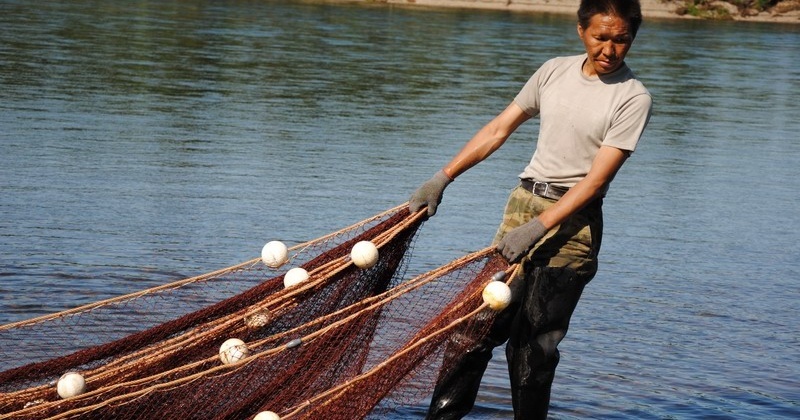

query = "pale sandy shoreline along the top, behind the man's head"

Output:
[[340, 0, 800, 24]]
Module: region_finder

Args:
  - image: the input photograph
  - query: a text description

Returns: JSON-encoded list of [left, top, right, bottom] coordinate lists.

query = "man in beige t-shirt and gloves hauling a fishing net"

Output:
[[409, 0, 652, 419]]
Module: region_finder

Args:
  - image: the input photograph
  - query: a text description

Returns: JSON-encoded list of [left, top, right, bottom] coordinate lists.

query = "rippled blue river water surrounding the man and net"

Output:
[[0, 0, 800, 419]]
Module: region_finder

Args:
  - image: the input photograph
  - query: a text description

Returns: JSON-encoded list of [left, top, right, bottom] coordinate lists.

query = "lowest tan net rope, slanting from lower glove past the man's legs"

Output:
[[281, 260, 521, 420]]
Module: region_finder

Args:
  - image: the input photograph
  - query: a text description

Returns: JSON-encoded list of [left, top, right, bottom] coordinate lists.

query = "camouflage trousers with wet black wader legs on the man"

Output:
[[427, 186, 603, 420]]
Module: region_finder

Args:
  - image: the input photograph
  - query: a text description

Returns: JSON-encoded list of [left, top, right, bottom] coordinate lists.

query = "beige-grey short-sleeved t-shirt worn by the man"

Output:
[[514, 54, 652, 188]]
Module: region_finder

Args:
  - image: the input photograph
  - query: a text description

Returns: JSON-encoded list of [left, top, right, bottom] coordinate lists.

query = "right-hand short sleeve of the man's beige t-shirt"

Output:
[[603, 93, 653, 152]]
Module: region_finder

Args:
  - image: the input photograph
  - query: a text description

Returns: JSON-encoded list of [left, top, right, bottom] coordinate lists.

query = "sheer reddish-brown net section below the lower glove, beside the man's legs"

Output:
[[282, 248, 516, 420]]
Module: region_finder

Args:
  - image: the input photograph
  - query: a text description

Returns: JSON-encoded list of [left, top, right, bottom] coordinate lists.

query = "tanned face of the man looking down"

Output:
[[578, 14, 633, 76]]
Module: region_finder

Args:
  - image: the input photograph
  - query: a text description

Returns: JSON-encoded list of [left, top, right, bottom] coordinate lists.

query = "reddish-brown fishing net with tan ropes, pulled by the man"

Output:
[[0, 206, 510, 419]]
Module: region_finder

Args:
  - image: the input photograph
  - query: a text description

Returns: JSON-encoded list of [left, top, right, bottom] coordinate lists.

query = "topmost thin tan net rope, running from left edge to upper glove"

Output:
[[0, 202, 406, 331]]
